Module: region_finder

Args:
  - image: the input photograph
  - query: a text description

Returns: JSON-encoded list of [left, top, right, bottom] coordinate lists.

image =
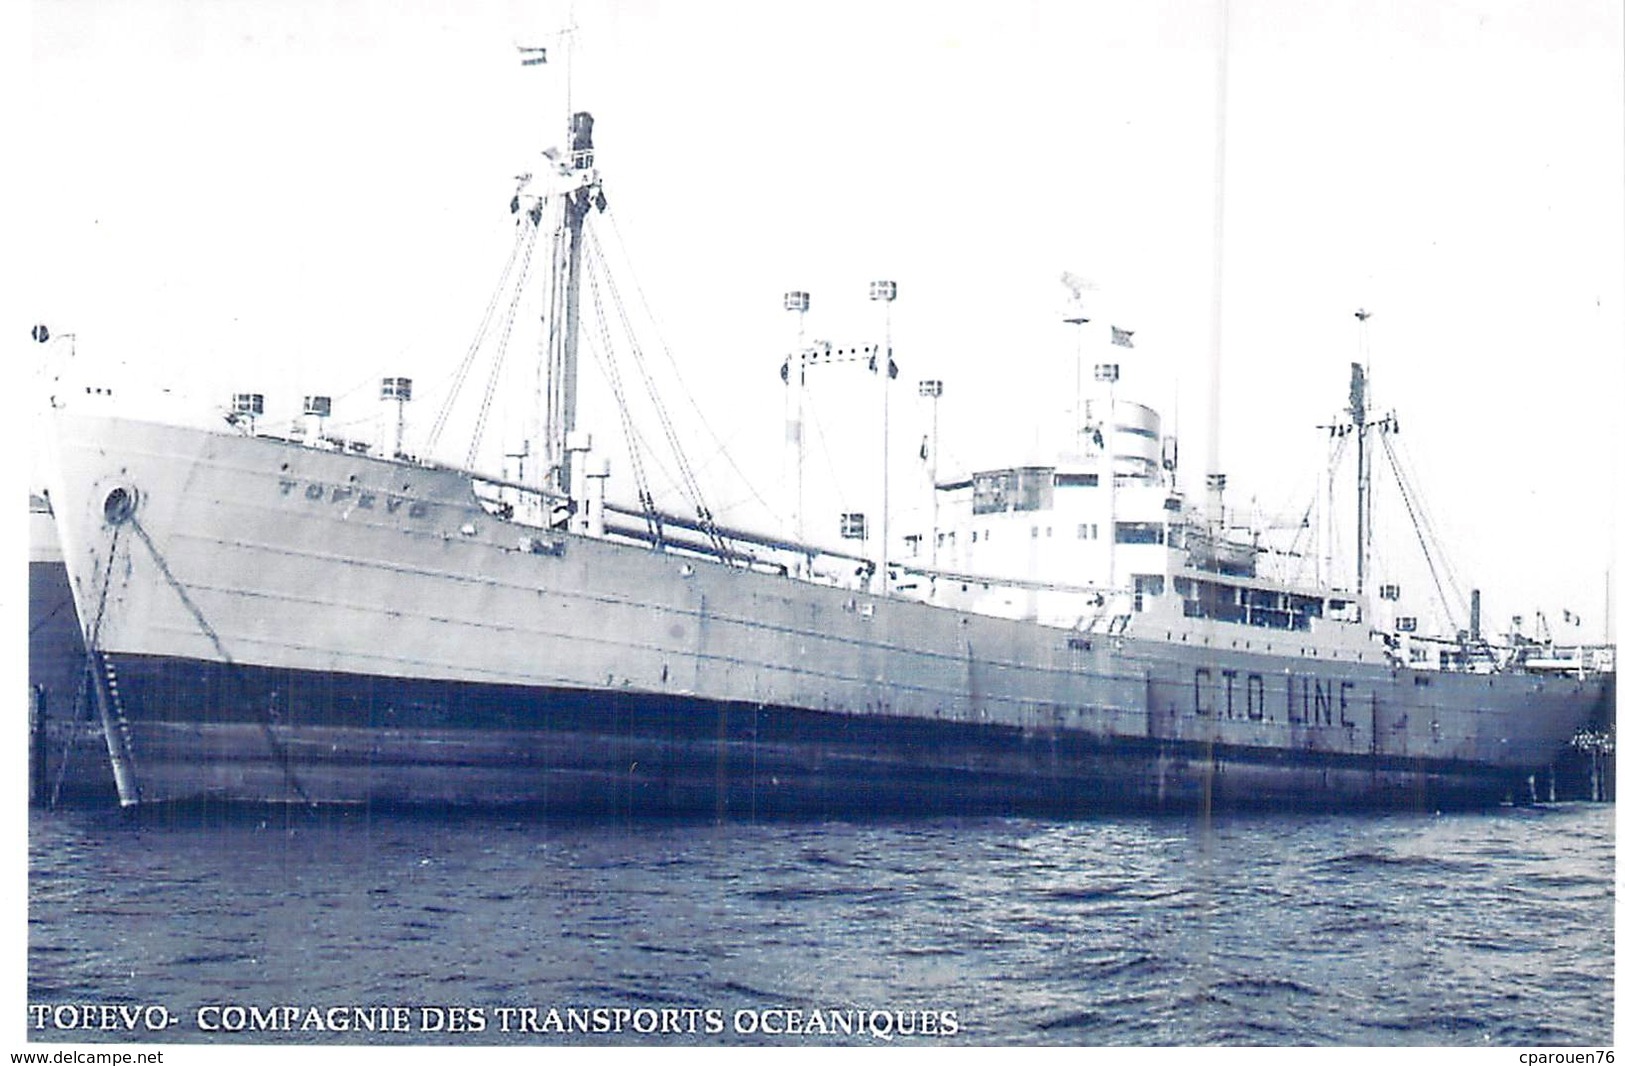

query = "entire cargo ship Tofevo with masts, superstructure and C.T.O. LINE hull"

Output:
[[38, 112, 1614, 817]]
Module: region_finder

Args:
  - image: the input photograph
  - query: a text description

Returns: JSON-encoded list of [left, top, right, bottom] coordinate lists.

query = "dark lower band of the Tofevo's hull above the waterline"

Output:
[[73, 657, 1544, 817]]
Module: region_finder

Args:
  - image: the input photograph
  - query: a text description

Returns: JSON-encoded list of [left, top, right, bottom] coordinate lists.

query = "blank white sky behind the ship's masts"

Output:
[[3, 0, 1625, 1053]]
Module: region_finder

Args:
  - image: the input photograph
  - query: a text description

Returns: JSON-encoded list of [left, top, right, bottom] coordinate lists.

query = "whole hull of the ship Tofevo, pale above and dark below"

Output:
[[54, 418, 1612, 816]]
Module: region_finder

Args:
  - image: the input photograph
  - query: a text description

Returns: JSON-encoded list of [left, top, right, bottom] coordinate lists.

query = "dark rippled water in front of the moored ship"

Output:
[[28, 804, 1614, 1047]]
